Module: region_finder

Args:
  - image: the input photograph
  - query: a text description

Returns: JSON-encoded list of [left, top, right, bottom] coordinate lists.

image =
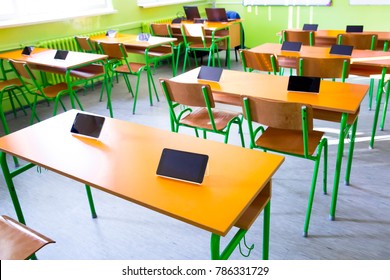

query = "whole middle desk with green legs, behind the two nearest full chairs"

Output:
[[172, 68, 368, 220]]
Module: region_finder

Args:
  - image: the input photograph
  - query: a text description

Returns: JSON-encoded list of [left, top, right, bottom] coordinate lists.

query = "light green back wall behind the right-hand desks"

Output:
[[216, 0, 390, 47]]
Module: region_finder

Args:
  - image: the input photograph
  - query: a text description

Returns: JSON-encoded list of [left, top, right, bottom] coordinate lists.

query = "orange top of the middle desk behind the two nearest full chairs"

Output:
[[172, 68, 369, 114]]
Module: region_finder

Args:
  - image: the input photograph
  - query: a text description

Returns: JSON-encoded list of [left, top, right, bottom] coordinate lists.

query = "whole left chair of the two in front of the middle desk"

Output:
[[160, 79, 245, 147]]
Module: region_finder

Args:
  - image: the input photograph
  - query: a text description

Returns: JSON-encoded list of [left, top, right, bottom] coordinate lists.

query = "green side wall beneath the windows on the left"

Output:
[[0, 0, 210, 51]]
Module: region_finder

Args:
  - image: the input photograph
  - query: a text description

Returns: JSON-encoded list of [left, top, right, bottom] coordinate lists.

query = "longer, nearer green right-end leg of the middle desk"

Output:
[[329, 113, 348, 221]]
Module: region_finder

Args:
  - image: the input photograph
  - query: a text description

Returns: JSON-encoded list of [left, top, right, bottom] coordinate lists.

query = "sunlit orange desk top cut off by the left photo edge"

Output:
[[0, 48, 107, 70]]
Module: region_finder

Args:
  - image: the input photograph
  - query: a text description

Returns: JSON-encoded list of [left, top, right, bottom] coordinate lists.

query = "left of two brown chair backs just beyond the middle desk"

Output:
[[240, 50, 280, 75]]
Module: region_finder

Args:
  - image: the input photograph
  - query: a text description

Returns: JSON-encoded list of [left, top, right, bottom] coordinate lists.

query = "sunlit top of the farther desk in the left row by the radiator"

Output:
[[90, 33, 177, 48]]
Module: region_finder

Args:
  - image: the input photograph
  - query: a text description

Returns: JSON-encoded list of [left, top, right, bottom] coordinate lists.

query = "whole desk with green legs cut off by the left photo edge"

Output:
[[0, 48, 113, 117]]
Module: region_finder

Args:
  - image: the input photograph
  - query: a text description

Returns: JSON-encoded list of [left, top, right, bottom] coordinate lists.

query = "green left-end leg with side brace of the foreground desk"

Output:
[[0, 152, 35, 224]]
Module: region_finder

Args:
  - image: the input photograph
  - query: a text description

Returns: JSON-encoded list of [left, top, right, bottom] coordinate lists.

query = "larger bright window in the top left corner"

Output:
[[0, 0, 115, 27]]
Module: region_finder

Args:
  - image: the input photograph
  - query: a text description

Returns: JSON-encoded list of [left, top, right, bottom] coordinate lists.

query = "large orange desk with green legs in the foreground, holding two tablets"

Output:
[[0, 110, 284, 259]]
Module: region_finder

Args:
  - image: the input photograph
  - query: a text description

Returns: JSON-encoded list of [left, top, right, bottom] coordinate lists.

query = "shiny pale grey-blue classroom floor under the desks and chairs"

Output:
[[0, 55, 390, 260]]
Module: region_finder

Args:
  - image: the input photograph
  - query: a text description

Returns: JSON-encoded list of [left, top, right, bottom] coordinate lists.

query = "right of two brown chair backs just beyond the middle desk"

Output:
[[297, 57, 350, 81]]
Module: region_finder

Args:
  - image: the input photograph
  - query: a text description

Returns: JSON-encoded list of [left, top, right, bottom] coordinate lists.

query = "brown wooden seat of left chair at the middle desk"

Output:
[[180, 108, 240, 130]]
